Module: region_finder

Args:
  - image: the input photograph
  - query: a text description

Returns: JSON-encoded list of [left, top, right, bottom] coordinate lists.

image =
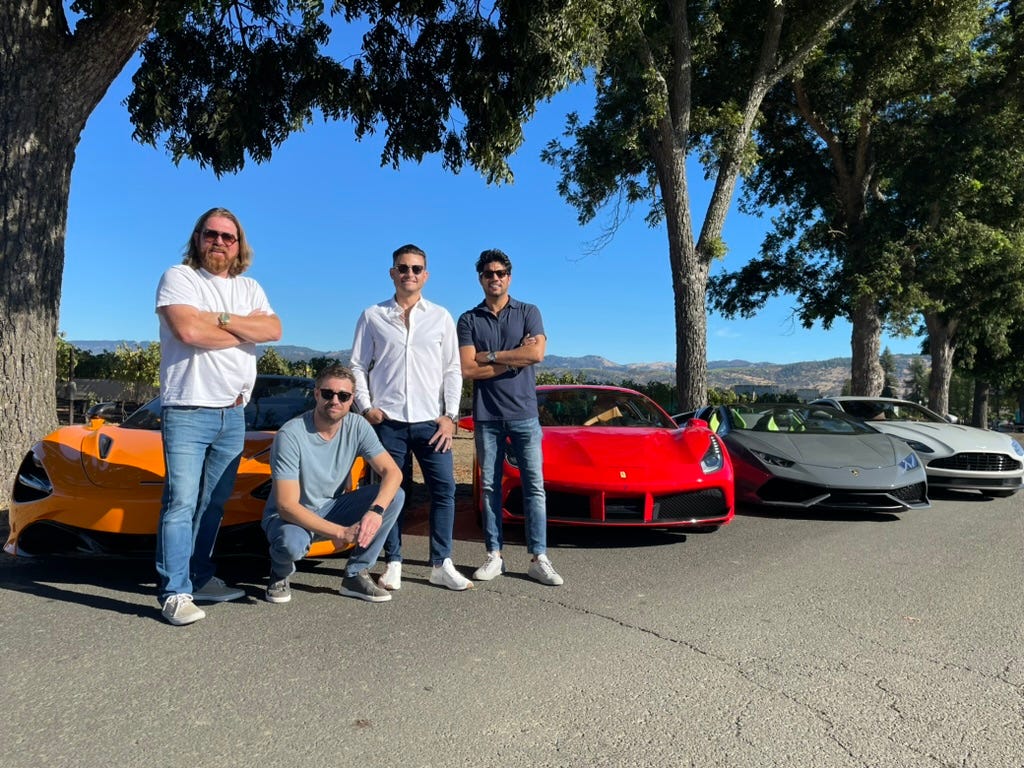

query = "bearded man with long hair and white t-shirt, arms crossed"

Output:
[[157, 208, 281, 626]]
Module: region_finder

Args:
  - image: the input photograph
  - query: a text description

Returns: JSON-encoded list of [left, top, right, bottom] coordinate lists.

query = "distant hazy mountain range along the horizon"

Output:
[[69, 340, 928, 395]]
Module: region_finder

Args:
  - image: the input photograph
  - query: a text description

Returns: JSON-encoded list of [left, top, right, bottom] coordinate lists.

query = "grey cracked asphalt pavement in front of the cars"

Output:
[[0, 494, 1024, 768]]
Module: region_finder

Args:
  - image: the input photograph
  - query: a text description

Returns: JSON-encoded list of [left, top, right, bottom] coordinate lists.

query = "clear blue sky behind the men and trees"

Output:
[[59, 65, 920, 364]]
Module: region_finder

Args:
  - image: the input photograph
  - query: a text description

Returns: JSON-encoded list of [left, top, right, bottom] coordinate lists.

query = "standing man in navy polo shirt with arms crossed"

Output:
[[457, 249, 562, 587]]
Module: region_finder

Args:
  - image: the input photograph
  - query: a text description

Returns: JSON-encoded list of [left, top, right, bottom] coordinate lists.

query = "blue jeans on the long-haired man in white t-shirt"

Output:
[[157, 406, 246, 602]]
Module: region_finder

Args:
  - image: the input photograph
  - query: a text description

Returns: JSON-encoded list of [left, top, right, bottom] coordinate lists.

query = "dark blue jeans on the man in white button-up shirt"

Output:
[[376, 421, 455, 565]]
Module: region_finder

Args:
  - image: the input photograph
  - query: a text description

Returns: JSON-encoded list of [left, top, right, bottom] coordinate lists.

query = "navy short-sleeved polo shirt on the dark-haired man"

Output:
[[456, 296, 547, 421]]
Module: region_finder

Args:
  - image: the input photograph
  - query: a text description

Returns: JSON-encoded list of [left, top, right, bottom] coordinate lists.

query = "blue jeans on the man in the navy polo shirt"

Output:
[[473, 419, 548, 555]]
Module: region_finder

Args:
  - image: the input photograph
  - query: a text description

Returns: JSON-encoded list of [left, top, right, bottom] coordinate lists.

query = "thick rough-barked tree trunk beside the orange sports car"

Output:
[[0, 2, 154, 507]]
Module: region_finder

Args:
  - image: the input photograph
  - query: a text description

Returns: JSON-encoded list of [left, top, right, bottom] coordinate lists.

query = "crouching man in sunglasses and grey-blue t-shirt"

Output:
[[263, 366, 404, 603]]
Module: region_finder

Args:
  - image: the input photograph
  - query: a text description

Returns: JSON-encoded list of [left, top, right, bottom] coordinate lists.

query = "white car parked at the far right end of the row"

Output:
[[811, 395, 1024, 497]]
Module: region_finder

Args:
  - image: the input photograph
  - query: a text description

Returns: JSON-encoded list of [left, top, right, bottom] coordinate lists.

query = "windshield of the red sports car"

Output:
[[537, 389, 676, 429]]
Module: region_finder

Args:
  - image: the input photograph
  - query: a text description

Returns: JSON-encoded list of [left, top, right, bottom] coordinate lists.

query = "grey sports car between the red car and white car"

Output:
[[695, 403, 931, 512]]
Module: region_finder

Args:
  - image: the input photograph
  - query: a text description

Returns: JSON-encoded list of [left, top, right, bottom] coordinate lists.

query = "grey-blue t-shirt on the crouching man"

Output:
[[263, 411, 384, 518]]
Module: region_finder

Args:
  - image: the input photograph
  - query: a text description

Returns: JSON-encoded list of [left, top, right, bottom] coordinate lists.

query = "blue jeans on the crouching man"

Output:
[[263, 485, 406, 581]]
